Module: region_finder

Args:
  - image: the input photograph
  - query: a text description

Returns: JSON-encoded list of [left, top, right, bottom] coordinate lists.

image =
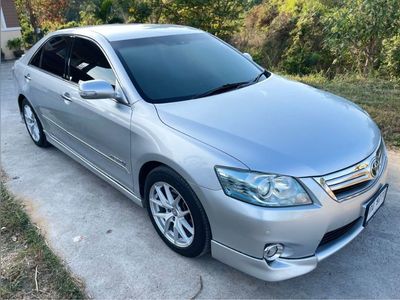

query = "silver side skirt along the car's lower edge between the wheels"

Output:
[[45, 132, 143, 207]]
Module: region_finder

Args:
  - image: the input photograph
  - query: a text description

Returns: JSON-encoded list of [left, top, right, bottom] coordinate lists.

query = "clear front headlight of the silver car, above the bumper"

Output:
[[215, 167, 312, 207]]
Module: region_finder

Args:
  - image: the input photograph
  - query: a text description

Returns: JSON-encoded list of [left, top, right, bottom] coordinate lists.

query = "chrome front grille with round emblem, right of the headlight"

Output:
[[314, 140, 387, 202]]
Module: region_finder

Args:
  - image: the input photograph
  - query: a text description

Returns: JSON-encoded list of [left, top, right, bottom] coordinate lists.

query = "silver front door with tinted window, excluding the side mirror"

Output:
[[52, 37, 133, 190]]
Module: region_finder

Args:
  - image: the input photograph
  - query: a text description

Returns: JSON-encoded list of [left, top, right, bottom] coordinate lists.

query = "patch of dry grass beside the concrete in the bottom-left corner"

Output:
[[0, 177, 88, 299]]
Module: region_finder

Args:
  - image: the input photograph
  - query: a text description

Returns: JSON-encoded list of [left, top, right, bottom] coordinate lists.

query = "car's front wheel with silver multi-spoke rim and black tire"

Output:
[[144, 166, 211, 257]]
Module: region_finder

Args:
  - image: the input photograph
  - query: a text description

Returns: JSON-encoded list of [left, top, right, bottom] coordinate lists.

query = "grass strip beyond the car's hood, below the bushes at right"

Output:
[[287, 74, 400, 148]]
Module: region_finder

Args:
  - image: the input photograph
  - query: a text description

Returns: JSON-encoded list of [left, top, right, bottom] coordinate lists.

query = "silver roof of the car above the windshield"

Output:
[[57, 24, 203, 42]]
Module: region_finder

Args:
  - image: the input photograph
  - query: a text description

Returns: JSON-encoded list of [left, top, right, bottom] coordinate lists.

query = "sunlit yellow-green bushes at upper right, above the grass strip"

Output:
[[233, 0, 400, 76]]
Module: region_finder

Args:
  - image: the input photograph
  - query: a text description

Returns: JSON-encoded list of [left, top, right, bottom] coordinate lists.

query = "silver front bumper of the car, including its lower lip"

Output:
[[196, 157, 387, 281]]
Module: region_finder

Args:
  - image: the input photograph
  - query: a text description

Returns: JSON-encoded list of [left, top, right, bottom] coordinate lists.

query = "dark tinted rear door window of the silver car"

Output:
[[40, 36, 68, 77]]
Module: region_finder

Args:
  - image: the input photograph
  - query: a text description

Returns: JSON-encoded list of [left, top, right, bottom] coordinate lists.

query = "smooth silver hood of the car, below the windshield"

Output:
[[156, 74, 380, 177]]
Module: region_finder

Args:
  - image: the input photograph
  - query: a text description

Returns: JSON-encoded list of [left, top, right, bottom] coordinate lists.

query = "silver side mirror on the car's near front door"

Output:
[[79, 80, 119, 99]]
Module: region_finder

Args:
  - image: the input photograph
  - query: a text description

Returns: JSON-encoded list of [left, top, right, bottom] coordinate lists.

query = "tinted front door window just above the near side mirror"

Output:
[[69, 38, 116, 86]]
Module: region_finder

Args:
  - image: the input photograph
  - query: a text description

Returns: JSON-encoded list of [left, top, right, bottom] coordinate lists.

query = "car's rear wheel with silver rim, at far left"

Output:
[[21, 99, 50, 148]]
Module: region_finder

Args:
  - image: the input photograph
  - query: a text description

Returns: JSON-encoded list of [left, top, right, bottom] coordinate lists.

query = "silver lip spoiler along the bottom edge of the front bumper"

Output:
[[211, 219, 364, 281]]
